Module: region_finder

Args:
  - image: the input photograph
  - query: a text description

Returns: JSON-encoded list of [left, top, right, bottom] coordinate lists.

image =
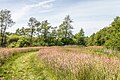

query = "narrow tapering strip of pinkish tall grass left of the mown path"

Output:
[[0, 47, 40, 66]]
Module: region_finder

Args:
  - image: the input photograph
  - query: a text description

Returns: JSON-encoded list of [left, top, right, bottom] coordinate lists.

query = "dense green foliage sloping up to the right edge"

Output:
[[88, 17, 120, 50]]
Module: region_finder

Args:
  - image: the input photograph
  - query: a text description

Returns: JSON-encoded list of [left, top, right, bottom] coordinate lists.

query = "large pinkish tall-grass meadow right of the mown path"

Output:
[[38, 47, 120, 80]]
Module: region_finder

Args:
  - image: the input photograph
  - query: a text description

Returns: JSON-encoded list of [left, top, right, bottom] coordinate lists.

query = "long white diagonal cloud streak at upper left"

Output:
[[12, 0, 55, 21]]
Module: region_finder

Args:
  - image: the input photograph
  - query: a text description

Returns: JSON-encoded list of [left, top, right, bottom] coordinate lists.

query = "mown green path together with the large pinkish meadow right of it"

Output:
[[0, 46, 120, 80]]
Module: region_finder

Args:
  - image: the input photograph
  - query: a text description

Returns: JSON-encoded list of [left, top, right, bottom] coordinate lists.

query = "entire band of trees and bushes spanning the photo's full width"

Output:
[[0, 9, 120, 50]]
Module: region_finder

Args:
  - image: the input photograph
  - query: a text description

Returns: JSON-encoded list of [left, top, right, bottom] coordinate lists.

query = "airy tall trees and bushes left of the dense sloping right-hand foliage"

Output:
[[0, 9, 86, 47]]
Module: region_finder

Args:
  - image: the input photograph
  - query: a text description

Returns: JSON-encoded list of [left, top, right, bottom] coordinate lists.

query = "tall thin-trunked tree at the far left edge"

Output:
[[0, 9, 15, 47]]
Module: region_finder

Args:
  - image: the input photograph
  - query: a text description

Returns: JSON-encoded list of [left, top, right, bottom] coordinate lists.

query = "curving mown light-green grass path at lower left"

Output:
[[0, 52, 54, 80]]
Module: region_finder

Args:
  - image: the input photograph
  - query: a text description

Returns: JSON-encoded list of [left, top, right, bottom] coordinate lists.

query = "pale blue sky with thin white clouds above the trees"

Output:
[[0, 0, 120, 36]]
